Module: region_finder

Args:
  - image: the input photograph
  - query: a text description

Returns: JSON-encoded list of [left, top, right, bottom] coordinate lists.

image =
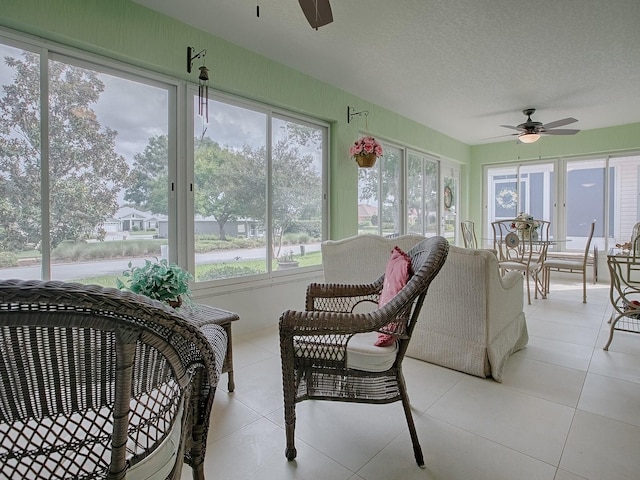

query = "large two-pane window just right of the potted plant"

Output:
[[193, 97, 328, 282]]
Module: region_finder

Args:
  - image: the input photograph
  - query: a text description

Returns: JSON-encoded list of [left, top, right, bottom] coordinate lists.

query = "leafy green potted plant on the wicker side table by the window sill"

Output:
[[116, 258, 193, 308]]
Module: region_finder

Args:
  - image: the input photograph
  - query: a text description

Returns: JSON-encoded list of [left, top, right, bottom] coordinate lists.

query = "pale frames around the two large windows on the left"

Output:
[[0, 27, 331, 295]]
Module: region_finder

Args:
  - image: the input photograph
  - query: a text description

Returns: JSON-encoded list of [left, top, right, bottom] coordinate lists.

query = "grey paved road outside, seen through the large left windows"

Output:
[[0, 243, 320, 281]]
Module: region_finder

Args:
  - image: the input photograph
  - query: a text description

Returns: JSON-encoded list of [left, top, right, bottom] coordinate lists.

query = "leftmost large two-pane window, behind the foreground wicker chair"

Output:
[[0, 38, 173, 286]]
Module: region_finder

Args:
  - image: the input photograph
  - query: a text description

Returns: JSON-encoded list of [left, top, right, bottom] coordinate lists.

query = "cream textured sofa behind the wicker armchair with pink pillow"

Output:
[[322, 235, 528, 382]]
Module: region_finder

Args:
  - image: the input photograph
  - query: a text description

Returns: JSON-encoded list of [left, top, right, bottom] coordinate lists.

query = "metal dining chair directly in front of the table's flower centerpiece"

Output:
[[491, 220, 548, 305]]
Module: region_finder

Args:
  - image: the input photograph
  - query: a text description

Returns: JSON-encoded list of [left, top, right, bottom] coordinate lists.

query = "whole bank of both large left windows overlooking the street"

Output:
[[0, 32, 328, 286]]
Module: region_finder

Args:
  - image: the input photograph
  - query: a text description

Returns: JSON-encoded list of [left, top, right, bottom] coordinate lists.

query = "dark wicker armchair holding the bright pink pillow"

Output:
[[280, 237, 449, 466]]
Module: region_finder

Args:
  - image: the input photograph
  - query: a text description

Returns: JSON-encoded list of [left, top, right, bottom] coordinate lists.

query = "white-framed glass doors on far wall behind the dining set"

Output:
[[485, 155, 640, 251]]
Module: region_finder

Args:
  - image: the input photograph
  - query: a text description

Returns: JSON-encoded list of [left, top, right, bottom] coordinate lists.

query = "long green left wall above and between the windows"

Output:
[[0, 0, 470, 238]]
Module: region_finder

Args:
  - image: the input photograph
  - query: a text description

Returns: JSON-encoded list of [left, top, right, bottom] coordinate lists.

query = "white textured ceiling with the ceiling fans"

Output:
[[131, 0, 640, 144]]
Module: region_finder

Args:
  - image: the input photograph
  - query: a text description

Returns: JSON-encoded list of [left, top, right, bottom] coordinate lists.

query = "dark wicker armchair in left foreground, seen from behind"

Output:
[[0, 280, 226, 479]]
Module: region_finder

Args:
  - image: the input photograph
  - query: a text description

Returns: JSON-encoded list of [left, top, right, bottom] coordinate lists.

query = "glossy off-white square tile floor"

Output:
[[183, 281, 640, 480]]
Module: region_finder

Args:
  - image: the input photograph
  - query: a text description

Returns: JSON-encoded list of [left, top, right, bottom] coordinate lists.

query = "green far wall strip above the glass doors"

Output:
[[468, 123, 640, 229]]
